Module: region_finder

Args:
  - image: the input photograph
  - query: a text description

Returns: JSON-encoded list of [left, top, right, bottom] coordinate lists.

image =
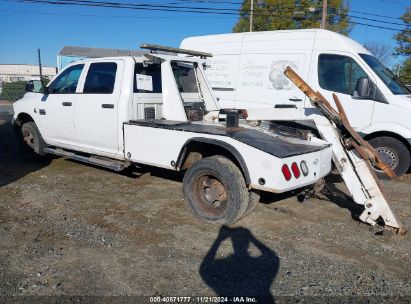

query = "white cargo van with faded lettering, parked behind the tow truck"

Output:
[[181, 29, 411, 175]]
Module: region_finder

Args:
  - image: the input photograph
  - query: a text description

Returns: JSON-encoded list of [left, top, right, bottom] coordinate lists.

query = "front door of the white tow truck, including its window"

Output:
[[36, 64, 84, 146]]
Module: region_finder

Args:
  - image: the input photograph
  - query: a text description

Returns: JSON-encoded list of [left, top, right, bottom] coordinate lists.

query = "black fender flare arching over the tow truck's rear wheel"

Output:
[[176, 137, 251, 185]]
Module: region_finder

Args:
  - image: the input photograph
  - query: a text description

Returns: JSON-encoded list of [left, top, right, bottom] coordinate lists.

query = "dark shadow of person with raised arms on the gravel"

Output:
[[199, 226, 280, 303]]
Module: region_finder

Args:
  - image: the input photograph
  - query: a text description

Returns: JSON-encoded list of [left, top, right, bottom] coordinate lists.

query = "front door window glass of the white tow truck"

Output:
[[49, 64, 84, 94]]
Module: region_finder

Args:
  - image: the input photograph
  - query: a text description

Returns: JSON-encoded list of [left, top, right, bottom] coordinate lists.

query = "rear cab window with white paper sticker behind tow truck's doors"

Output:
[[134, 63, 162, 93]]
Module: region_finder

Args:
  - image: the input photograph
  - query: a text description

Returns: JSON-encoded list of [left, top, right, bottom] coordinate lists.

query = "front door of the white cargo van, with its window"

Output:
[[310, 52, 375, 132]]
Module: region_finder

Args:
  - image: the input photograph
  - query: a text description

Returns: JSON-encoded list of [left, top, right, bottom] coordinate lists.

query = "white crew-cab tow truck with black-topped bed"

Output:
[[14, 46, 331, 223]]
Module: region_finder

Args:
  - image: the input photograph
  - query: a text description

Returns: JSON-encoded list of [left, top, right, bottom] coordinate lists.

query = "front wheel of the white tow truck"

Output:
[[20, 121, 46, 160]]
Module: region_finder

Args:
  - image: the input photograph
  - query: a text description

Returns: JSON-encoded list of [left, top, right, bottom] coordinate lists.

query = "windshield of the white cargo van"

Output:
[[359, 54, 410, 95]]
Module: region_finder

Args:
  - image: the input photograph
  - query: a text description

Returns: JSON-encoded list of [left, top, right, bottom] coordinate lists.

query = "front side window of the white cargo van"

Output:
[[318, 54, 368, 95]]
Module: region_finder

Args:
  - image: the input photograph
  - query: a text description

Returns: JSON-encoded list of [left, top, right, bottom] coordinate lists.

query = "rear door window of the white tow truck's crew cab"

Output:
[[83, 62, 117, 94]]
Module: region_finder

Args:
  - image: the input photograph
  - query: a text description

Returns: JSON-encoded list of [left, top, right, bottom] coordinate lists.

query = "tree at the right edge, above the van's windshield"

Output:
[[394, 6, 411, 83]]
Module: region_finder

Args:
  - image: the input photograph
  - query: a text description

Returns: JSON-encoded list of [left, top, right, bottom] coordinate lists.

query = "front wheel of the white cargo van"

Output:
[[369, 136, 411, 179]]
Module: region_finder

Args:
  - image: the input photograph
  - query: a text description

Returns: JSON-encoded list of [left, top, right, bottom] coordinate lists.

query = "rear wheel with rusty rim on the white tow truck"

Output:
[[183, 156, 249, 224]]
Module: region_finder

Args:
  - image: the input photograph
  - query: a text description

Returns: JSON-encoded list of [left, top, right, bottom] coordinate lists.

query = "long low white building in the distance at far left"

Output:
[[0, 64, 56, 83]]
